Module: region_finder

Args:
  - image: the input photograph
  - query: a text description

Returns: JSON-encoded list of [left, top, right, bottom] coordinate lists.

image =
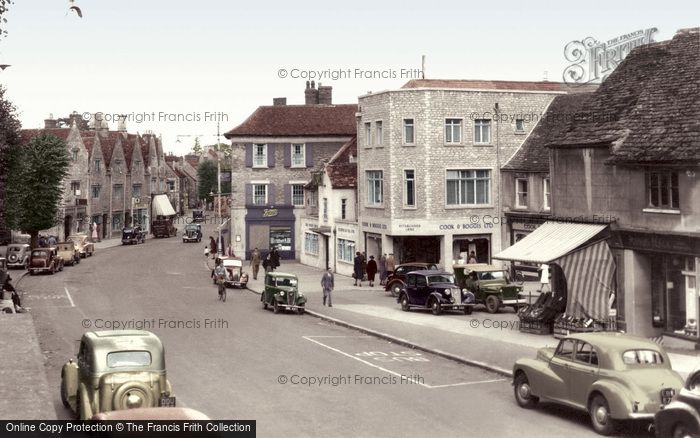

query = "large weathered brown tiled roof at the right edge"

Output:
[[550, 28, 700, 165]]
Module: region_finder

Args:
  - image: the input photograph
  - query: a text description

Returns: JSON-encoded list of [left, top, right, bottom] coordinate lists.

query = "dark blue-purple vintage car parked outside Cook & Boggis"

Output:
[[398, 270, 475, 315]]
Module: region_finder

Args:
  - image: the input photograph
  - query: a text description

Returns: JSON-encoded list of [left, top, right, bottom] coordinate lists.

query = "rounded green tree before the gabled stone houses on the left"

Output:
[[5, 134, 70, 247]]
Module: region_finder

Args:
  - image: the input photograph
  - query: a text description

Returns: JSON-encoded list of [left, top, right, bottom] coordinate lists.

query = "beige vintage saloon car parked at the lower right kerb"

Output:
[[513, 332, 683, 435]]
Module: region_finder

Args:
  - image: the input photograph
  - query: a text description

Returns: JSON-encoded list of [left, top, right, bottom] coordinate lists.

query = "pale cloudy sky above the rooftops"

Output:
[[0, 0, 700, 155]]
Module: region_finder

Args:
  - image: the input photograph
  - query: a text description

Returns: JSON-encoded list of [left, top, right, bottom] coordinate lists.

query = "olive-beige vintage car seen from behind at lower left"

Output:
[[61, 330, 175, 420]]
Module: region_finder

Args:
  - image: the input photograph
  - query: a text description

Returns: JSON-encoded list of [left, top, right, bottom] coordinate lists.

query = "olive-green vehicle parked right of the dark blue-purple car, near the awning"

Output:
[[453, 263, 527, 313]]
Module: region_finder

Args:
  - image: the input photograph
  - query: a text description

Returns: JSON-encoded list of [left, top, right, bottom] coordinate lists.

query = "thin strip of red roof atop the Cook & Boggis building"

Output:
[[401, 79, 596, 93]]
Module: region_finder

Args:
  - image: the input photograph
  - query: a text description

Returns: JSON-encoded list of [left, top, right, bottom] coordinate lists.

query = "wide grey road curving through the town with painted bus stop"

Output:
[[16, 222, 650, 438]]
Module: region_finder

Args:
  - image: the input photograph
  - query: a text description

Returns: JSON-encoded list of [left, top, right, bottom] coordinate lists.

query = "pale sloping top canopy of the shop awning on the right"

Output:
[[493, 221, 607, 263]]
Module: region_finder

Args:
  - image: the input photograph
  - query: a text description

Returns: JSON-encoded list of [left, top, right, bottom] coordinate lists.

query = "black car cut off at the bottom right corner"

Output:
[[654, 370, 700, 438]]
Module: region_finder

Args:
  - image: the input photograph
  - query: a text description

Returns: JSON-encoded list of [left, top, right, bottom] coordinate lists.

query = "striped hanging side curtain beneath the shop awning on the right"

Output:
[[554, 241, 615, 320]]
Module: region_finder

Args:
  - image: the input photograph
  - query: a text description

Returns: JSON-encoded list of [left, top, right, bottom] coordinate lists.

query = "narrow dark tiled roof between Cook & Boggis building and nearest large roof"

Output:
[[503, 93, 591, 172]]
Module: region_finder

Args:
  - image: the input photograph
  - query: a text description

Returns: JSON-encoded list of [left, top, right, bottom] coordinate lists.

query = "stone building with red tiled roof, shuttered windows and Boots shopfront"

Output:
[[224, 82, 357, 259]]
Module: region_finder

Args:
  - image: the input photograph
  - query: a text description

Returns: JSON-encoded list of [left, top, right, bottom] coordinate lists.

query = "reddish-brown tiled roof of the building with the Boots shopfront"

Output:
[[224, 105, 357, 139]]
